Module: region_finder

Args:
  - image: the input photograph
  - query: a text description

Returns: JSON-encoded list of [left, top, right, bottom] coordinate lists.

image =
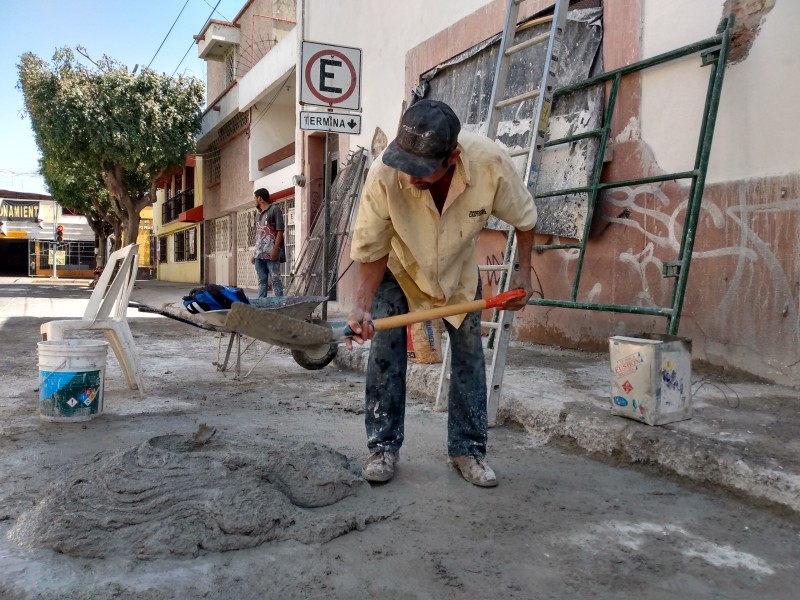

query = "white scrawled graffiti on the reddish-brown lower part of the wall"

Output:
[[482, 183, 800, 347]]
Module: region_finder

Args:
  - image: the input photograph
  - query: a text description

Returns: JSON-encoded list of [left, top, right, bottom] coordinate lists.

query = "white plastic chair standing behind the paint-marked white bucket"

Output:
[[39, 244, 144, 396]]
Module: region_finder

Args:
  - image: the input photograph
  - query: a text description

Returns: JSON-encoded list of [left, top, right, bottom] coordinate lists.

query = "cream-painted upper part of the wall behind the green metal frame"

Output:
[[640, 0, 800, 183]]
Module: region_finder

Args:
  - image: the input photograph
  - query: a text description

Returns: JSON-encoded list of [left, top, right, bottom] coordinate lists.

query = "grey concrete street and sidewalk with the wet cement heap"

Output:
[[0, 279, 800, 600]]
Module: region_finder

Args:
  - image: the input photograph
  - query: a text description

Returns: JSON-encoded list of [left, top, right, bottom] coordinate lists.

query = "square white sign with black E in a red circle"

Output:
[[300, 41, 361, 110]]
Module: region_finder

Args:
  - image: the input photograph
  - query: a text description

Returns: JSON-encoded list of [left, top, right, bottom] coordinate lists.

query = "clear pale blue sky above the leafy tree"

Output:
[[0, 0, 244, 194]]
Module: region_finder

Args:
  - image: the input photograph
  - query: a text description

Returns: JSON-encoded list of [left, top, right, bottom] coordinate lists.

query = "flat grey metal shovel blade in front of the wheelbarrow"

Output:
[[225, 302, 333, 350]]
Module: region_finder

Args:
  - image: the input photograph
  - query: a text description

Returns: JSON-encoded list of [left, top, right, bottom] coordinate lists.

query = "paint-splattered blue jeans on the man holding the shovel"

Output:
[[364, 270, 487, 458]]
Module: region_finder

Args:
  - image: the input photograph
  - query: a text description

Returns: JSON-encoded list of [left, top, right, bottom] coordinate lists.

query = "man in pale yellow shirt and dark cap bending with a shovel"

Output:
[[347, 100, 536, 487]]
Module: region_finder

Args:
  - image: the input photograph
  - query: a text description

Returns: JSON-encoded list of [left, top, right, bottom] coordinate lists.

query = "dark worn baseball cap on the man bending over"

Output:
[[383, 100, 461, 177]]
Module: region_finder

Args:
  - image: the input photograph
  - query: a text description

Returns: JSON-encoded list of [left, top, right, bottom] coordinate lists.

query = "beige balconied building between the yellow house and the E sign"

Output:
[[195, 0, 296, 288]]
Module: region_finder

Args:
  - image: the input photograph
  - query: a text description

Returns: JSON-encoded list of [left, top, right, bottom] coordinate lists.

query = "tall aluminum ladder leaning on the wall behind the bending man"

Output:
[[434, 0, 569, 426]]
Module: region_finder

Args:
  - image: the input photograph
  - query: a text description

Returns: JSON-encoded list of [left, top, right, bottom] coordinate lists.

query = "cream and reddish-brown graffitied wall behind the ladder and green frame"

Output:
[[328, 0, 800, 386]]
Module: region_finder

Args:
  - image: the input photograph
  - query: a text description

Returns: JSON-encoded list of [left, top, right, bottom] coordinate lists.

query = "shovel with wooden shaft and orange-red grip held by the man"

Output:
[[225, 290, 525, 353]]
